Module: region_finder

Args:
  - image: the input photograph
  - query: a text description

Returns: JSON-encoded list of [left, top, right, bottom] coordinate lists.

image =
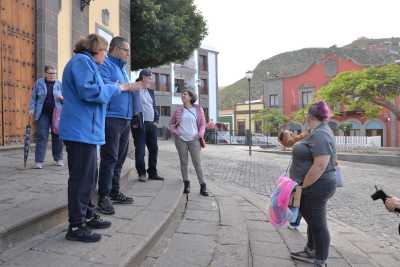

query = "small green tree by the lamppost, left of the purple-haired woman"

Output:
[[253, 108, 288, 135]]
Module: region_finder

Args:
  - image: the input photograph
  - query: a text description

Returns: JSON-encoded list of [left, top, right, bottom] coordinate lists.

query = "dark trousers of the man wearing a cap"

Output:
[[132, 121, 158, 177]]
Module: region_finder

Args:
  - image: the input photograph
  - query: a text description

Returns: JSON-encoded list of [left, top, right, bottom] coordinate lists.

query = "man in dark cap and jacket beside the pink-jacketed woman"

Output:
[[132, 69, 164, 182]]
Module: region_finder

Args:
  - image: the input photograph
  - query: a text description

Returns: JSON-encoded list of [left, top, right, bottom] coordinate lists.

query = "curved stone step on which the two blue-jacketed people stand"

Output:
[[0, 161, 183, 267]]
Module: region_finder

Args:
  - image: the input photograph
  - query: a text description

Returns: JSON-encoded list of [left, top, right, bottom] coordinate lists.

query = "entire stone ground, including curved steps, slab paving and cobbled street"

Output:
[[0, 141, 400, 267]]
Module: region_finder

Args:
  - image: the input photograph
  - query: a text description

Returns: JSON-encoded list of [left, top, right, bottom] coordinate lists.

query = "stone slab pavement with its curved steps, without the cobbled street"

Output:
[[0, 142, 400, 267]]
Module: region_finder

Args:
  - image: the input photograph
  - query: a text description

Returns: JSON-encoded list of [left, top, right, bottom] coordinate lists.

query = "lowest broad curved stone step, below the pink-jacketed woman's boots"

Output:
[[141, 182, 295, 267]]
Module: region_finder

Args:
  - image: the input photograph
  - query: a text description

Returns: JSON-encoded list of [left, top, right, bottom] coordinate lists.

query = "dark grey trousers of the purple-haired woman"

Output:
[[300, 176, 336, 263]]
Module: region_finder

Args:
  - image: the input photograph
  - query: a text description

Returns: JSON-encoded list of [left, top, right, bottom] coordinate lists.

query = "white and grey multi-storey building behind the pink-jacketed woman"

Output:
[[132, 48, 218, 132]]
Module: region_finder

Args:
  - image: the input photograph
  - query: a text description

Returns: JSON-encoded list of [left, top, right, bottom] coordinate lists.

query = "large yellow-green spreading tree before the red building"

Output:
[[318, 64, 400, 120]]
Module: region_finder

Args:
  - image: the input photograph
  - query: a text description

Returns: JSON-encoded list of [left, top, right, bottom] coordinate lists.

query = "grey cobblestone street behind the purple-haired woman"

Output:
[[160, 142, 400, 252]]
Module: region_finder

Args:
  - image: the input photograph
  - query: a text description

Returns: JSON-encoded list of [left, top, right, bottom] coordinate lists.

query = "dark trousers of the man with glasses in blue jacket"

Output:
[[98, 118, 130, 196]]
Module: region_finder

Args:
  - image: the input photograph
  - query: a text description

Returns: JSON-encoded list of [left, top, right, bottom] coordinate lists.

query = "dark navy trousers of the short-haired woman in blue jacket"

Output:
[[65, 141, 97, 226]]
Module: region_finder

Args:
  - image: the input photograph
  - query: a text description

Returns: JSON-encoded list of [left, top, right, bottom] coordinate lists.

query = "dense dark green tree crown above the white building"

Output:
[[131, 0, 207, 70]]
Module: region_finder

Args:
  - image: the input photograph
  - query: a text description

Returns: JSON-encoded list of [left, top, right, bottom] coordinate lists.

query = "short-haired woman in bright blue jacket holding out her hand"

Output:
[[60, 34, 142, 242]]
